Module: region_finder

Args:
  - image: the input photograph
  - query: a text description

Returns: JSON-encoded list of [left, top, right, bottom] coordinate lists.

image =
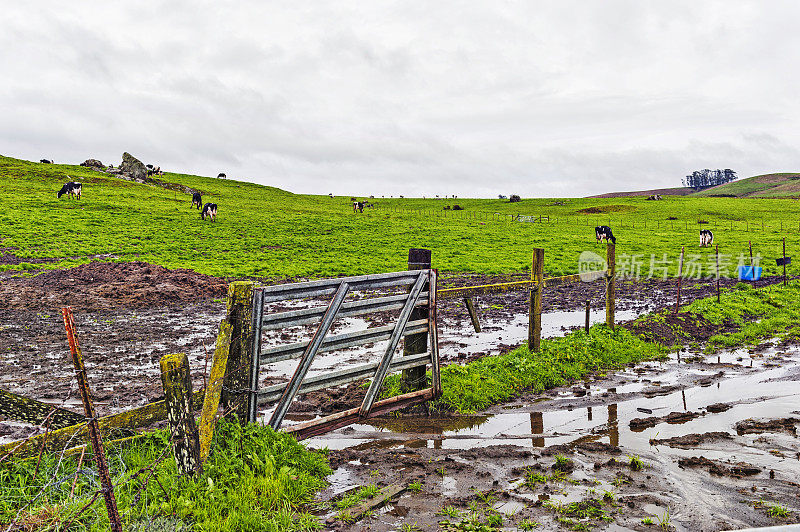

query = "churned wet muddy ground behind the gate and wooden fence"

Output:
[[0, 260, 764, 422]]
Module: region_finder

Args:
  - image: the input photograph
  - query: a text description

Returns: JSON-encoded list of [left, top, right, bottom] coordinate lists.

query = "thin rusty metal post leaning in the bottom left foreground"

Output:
[[61, 307, 122, 532]]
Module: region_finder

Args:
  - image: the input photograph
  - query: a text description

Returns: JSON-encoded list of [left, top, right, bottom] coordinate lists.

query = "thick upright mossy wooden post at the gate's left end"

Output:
[[222, 281, 255, 422]]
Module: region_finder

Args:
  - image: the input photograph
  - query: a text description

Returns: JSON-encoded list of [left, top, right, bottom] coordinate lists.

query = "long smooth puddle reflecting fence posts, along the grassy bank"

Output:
[[308, 349, 800, 474]]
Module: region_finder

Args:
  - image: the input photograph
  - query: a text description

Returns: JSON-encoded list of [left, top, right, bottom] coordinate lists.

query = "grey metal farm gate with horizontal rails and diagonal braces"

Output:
[[247, 269, 441, 439]]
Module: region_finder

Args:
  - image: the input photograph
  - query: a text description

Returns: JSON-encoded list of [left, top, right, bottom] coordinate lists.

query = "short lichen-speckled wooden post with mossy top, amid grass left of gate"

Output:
[[161, 353, 203, 476]]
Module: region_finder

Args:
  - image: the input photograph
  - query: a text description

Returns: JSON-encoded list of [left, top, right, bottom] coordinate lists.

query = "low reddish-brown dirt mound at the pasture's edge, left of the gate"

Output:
[[0, 262, 228, 311]]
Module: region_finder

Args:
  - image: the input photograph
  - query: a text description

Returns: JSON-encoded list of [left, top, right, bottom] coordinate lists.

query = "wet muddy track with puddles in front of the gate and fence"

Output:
[[309, 347, 800, 530]]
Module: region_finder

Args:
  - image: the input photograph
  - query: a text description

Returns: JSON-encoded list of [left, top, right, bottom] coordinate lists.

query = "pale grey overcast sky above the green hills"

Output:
[[0, 0, 800, 197]]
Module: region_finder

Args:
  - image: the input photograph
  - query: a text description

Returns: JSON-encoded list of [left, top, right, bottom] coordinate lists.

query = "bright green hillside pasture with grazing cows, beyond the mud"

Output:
[[0, 157, 800, 277]]
